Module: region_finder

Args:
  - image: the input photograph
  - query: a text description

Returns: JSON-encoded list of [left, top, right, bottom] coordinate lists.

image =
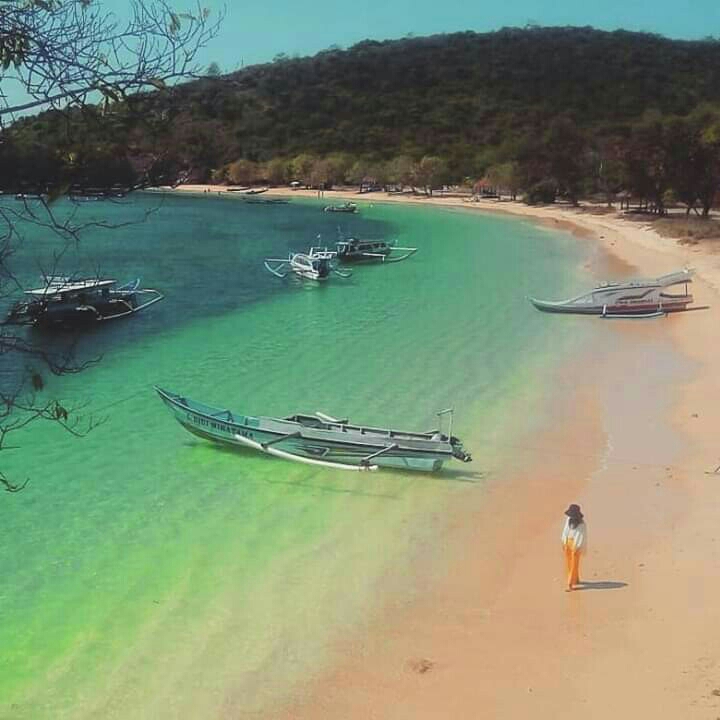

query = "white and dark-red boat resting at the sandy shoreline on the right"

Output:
[[528, 269, 693, 318]]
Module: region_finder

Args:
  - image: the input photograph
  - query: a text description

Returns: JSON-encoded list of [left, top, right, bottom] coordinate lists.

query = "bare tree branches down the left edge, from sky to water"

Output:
[[0, 0, 224, 493]]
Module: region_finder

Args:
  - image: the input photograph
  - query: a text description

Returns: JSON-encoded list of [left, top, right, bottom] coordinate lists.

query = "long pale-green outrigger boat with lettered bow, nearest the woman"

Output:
[[155, 387, 472, 471]]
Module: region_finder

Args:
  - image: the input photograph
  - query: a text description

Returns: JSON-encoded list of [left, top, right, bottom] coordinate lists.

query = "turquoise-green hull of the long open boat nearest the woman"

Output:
[[156, 388, 462, 472]]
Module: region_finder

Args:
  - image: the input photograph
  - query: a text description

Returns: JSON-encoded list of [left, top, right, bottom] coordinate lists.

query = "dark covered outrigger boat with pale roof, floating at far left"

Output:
[[6, 276, 164, 328]]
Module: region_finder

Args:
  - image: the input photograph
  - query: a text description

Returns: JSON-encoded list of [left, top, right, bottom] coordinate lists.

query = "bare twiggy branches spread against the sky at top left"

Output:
[[0, 0, 224, 119]]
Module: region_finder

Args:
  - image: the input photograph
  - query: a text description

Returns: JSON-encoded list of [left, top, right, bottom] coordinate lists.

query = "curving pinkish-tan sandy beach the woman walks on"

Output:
[[176, 186, 720, 720]]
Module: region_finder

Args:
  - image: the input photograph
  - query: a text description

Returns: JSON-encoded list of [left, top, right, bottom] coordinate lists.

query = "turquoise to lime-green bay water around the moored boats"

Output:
[[0, 196, 584, 720]]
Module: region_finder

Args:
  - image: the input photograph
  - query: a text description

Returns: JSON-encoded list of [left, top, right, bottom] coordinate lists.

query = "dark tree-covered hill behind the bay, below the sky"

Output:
[[0, 28, 720, 207]]
